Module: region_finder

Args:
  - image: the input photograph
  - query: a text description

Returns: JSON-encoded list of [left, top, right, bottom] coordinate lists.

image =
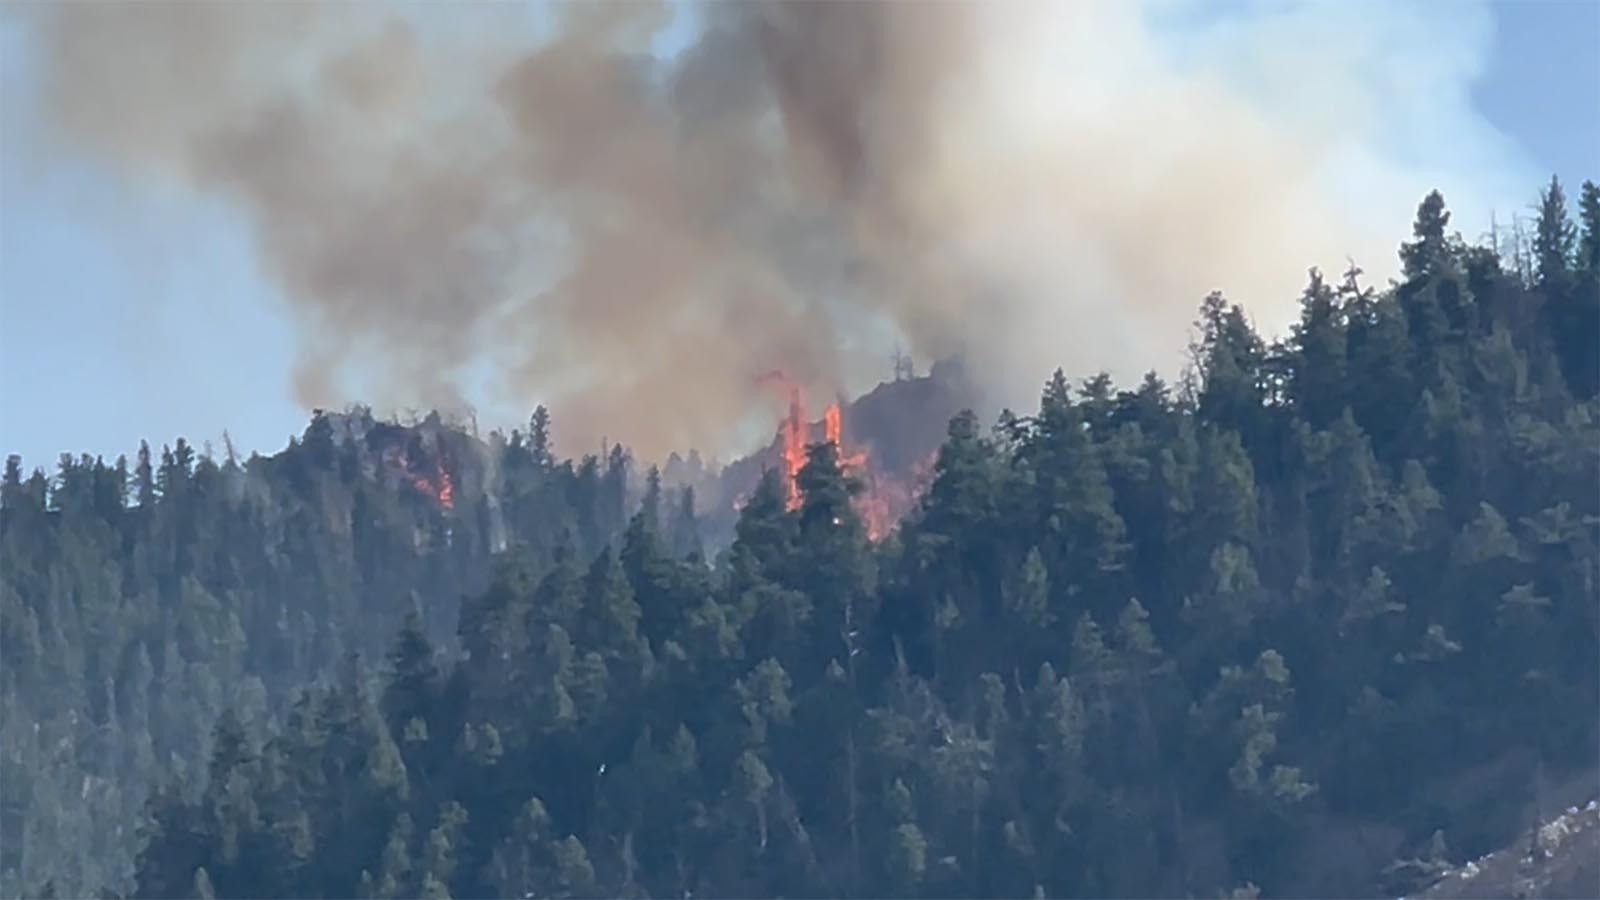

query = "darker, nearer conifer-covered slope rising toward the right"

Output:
[[84, 184, 1600, 897]]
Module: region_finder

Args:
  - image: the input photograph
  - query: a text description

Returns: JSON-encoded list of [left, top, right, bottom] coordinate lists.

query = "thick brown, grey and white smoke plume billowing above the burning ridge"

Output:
[[18, 0, 1530, 455]]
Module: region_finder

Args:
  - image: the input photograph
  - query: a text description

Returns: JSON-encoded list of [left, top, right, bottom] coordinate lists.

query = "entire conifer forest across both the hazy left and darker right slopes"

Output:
[[0, 181, 1600, 898]]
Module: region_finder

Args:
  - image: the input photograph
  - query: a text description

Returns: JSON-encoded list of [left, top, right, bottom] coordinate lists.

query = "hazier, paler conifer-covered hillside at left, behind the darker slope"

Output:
[[0, 410, 668, 897]]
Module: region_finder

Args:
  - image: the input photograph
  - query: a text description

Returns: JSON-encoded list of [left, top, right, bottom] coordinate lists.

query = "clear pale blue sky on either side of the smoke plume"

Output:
[[0, 0, 1600, 466]]
